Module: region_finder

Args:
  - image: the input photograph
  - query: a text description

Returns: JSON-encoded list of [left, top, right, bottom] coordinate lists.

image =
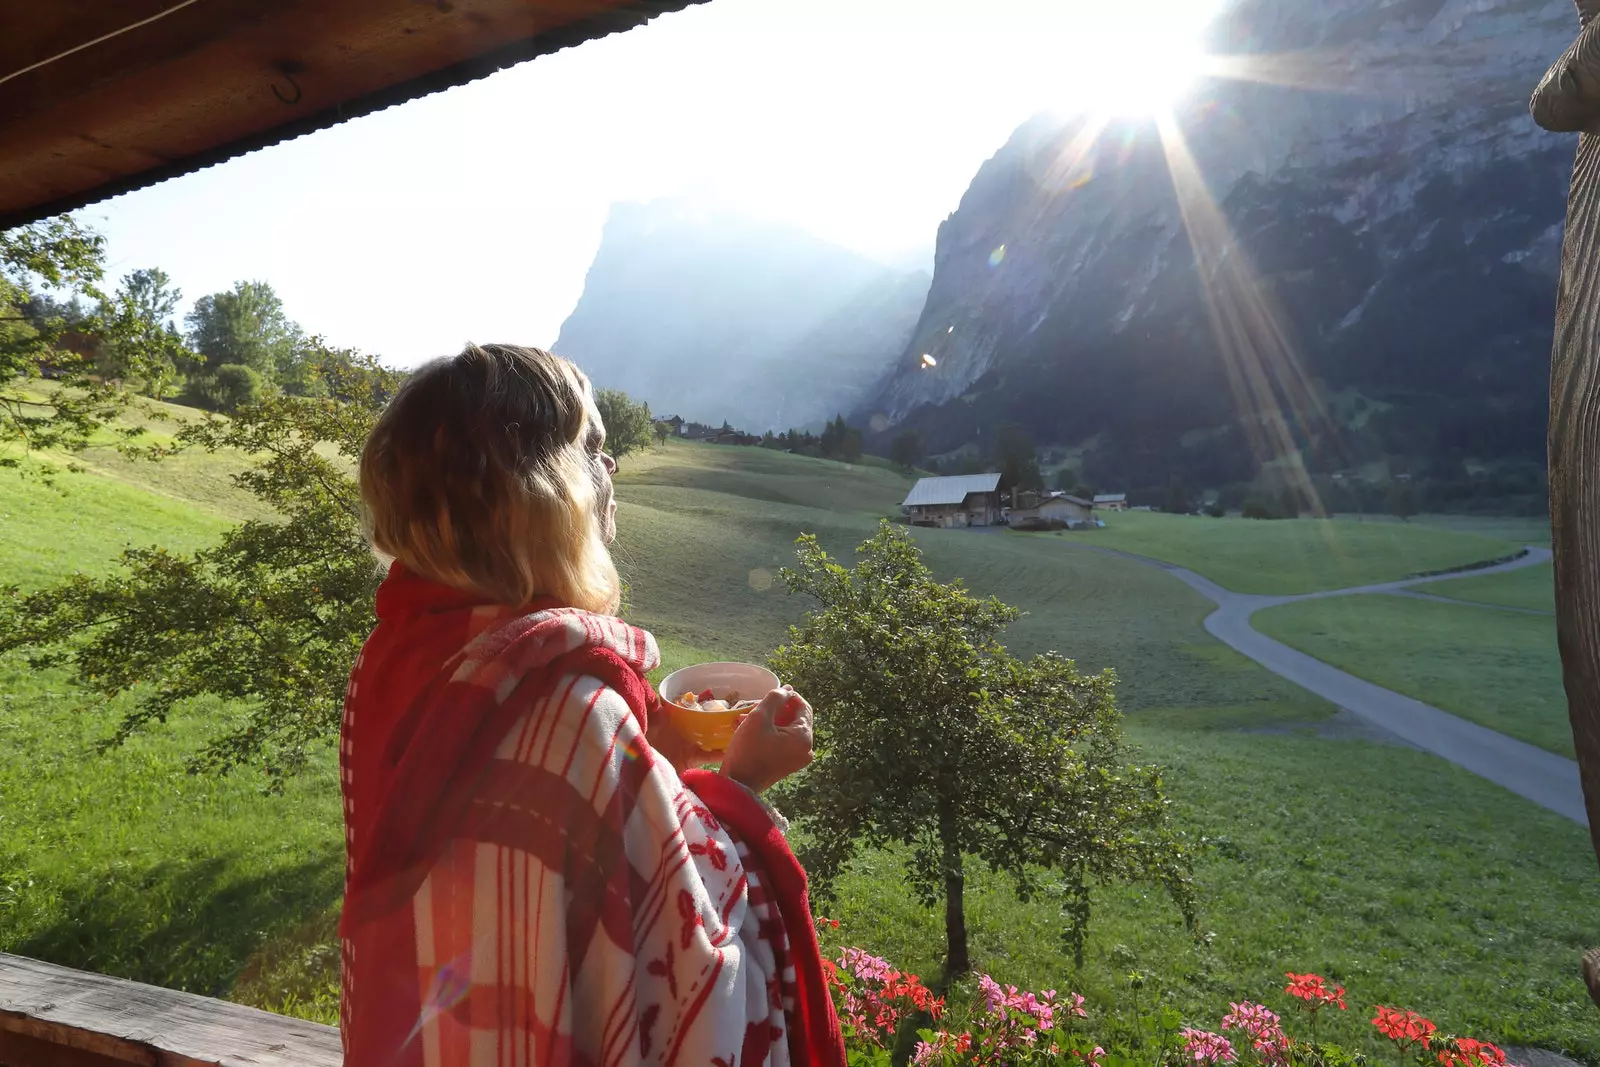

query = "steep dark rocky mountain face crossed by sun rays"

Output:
[[858, 0, 1576, 502]]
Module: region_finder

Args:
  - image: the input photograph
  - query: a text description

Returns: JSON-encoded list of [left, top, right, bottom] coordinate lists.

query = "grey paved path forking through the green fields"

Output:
[[1096, 545, 1589, 825]]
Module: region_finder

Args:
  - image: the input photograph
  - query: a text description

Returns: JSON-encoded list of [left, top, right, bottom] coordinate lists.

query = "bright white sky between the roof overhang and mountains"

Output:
[[82, 0, 1218, 366]]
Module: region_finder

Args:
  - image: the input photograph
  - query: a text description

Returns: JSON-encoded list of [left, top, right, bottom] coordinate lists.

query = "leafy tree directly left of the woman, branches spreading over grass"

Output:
[[0, 354, 400, 781]]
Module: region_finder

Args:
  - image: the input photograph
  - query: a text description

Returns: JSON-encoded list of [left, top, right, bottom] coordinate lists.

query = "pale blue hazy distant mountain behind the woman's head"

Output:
[[555, 198, 930, 434]]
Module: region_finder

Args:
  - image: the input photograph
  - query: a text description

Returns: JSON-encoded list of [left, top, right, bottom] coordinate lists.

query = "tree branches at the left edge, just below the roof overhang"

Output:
[[0, 216, 187, 466]]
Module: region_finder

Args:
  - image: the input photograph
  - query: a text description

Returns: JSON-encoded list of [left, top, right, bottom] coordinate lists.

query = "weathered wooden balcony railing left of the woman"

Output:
[[0, 952, 334, 1067]]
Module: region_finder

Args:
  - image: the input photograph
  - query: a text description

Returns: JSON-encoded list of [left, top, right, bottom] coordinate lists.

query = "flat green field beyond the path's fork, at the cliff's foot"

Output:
[[1077, 512, 1520, 595]]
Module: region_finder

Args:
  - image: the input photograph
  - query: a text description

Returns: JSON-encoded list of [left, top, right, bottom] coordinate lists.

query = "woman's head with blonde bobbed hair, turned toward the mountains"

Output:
[[360, 344, 621, 614]]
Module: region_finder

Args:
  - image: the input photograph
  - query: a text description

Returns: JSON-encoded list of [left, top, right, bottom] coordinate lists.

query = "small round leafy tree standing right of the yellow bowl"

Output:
[[773, 523, 1194, 977]]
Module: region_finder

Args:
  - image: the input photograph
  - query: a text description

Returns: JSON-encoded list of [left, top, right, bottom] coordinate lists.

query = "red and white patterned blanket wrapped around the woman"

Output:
[[339, 565, 843, 1067]]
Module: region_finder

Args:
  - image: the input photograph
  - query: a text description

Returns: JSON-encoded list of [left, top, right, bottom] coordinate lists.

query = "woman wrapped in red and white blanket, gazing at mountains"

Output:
[[341, 346, 843, 1067]]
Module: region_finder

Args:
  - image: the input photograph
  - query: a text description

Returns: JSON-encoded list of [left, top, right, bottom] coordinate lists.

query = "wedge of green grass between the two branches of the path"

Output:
[[1251, 591, 1573, 757]]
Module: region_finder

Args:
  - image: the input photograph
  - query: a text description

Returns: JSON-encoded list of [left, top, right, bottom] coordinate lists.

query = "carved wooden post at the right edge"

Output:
[[1531, 0, 1600, 1005]]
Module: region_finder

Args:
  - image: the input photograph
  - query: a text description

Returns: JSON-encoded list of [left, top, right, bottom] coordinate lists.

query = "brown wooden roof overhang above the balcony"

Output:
[[0, 0, 701, 230]]
